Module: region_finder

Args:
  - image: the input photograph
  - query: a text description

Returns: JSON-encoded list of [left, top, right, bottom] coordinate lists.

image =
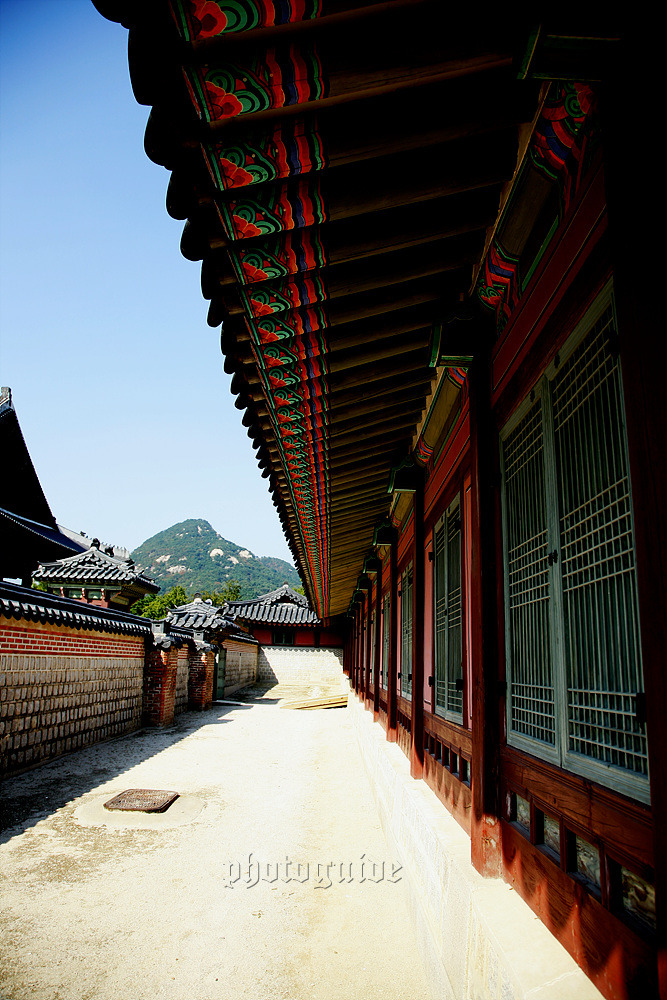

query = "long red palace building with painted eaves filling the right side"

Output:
[[91, 0, 667, 998]]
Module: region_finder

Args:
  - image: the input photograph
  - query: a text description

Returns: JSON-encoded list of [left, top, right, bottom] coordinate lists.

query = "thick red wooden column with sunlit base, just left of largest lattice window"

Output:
[[468, 344, 502, 876]]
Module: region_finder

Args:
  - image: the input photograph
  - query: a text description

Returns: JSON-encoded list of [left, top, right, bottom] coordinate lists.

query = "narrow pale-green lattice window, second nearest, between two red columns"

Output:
[[433, 497, 463, 722]]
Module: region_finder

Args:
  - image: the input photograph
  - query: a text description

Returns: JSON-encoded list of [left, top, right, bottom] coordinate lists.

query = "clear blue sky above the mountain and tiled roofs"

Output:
[[0, 0, 292, 562]]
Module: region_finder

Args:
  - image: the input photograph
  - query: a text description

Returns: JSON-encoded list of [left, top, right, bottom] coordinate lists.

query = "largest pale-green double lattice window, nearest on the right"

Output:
[[502, 292, 648, 800]]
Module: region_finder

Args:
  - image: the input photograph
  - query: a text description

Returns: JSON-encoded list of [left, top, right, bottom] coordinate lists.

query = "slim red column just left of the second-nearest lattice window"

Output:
[[410, 469, 424, 778]]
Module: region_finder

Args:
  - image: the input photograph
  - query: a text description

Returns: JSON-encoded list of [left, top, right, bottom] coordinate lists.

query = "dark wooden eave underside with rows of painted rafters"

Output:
[[96, 0, 539, 618]]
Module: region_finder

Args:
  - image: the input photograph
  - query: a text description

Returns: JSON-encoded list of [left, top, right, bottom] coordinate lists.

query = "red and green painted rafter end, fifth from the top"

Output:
[[229, 228, 327, 285]]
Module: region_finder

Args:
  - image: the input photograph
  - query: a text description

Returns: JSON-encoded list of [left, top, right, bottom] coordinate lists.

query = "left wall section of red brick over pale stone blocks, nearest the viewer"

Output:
[[0, 617, 144, 771]]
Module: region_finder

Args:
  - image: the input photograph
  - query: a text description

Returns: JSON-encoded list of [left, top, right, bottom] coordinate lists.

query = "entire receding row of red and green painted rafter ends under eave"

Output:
[[172, 0, 329, 614]]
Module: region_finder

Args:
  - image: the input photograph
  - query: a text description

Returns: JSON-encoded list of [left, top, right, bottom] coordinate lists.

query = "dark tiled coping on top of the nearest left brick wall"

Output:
[[0, 581, 152, 636]]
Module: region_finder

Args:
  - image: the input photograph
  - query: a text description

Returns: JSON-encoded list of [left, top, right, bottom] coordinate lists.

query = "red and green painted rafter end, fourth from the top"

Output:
[[217, 177, 327, 241]]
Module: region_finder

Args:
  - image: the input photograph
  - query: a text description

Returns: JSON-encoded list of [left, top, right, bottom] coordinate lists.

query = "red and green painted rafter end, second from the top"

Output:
[[184, 45, 325, 122]]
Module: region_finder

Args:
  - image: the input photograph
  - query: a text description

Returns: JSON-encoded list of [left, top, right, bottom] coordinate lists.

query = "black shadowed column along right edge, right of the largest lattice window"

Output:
[[603, 58, 667, 1000]]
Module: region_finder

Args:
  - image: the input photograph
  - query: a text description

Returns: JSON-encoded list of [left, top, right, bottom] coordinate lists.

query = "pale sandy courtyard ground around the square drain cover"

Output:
[[0, 696, 431, 1000]]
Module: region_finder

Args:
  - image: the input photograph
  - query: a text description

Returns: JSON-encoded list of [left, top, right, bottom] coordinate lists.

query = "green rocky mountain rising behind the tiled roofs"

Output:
[[132, 519, 301, 598]]
